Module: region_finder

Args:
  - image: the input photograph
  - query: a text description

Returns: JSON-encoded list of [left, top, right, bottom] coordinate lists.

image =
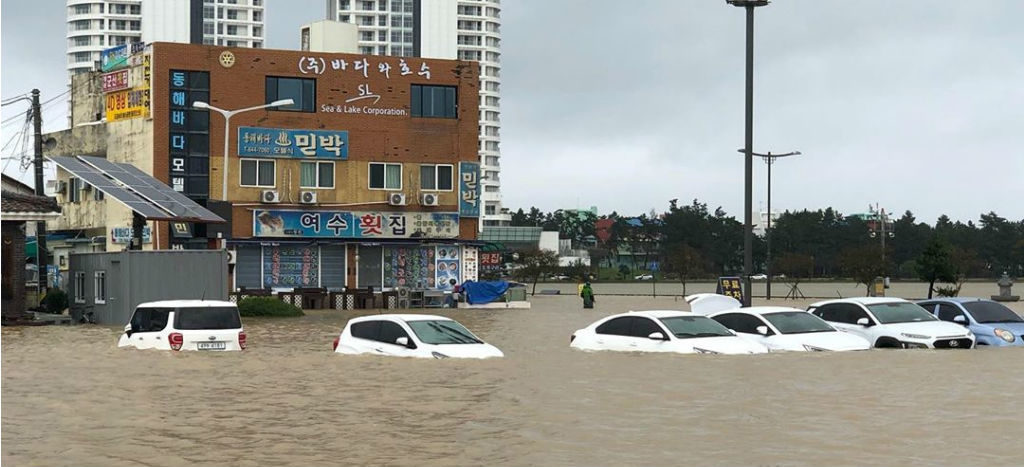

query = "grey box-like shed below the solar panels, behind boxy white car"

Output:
[[69, 250, 227, 326]]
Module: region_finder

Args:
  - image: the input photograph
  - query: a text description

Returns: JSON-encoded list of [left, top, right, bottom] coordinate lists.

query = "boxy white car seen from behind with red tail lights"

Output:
[[118, 300, 246, 350]]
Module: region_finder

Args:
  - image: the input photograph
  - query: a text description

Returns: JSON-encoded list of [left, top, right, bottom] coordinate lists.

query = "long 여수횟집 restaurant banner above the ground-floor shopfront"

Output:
[[253, 209, 459, 239]]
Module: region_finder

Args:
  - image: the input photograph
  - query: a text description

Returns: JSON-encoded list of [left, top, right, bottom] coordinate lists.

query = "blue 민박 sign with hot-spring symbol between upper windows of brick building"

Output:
[[239, 127, 348, 161]]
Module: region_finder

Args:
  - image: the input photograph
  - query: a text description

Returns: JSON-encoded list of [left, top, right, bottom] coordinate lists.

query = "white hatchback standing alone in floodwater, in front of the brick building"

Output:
[[334, 314, 505, 358]]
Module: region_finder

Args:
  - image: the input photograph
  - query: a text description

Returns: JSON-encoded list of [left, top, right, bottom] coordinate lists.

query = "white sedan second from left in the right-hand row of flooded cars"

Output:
[[709, 306, 871, 351]]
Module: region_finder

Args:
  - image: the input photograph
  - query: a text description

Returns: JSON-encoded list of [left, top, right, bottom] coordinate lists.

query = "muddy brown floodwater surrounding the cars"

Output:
[[2, 297, 1024, 466]]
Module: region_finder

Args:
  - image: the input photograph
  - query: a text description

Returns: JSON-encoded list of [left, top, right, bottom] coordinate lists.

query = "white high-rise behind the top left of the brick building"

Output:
[[68, 0, 264, 81]]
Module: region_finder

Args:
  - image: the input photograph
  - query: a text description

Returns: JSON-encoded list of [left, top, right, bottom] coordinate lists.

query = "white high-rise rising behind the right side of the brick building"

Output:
[[326, 0, 512, 226]]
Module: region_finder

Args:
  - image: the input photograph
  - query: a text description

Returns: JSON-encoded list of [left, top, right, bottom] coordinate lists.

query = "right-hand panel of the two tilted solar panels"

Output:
[[79, 156, 224, 222]]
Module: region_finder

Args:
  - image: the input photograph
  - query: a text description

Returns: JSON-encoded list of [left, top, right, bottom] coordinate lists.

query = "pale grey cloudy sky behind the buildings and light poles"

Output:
[[0, 0, 1024, 223]]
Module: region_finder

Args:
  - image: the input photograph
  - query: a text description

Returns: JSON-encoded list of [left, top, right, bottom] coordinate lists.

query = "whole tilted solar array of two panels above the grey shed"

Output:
[[47, 156, 224, 222]]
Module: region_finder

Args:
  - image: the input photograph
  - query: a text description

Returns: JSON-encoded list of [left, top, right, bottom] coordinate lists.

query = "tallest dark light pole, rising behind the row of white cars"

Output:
[[725, 0, 768, 306]]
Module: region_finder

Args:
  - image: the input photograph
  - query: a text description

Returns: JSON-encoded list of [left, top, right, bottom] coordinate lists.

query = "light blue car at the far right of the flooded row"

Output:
[[918, 297, 1024, 347]]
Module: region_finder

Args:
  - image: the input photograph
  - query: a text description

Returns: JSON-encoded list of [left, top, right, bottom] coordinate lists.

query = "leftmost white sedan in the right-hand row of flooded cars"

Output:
[[569, 310, 768, 354]]
